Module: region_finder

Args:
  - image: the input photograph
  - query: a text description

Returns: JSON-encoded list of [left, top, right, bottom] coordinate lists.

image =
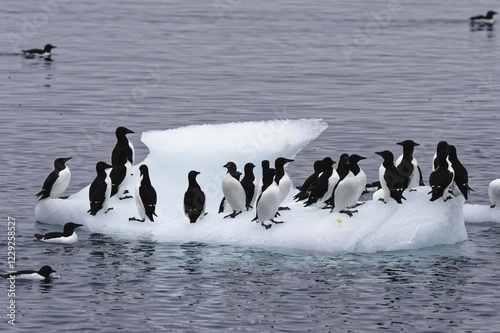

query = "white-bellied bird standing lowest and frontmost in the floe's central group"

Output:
[[256, 168, 283, 229]]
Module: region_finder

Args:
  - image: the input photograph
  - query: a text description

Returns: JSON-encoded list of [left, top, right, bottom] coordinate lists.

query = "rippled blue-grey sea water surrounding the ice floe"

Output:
[[0, 0, 500, 332]]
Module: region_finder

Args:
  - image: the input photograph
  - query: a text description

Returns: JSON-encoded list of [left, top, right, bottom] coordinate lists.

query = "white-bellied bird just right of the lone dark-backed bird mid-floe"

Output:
[[222, 162, 246, 218]]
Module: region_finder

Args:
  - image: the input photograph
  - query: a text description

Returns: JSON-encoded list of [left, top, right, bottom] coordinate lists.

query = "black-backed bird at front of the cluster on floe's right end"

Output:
[[429, 150, 455, 201]]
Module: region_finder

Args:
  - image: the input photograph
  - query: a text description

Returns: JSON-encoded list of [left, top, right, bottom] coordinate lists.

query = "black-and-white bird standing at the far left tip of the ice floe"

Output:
[[36, 157, 71, 200]]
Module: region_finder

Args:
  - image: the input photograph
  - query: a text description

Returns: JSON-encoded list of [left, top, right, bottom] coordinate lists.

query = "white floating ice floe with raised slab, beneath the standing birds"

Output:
[[35, 119, 472, 253]]
